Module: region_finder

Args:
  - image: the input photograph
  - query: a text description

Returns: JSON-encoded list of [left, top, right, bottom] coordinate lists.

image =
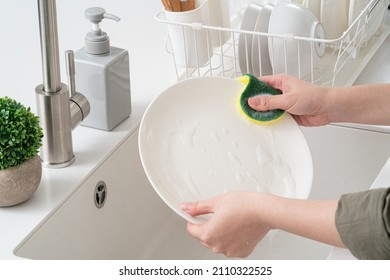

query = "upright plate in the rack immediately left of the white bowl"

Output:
[[252, 3, 274, 77]]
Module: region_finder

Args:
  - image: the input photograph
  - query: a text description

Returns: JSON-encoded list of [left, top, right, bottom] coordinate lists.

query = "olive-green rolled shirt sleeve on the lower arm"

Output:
[[335, 188, 390, 260]]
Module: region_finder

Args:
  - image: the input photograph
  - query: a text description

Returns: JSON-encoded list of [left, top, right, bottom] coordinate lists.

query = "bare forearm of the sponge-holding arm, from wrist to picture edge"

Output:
[[326, 84, 390, 125]]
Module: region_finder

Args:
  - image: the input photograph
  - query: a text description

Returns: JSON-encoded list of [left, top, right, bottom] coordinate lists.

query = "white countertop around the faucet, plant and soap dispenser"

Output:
[[0, 0, 175, 259]]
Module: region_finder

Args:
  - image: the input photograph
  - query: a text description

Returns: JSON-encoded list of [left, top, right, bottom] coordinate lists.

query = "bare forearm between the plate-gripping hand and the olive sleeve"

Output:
[[259, 196, 344, 247]]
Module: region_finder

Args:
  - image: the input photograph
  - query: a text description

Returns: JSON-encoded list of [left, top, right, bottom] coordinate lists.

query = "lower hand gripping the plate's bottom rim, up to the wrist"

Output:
[[182, 192, 271, 258]]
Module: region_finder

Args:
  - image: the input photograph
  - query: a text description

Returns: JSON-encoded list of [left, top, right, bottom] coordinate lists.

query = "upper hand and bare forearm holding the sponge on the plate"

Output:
[[248, 74, 390, 126]]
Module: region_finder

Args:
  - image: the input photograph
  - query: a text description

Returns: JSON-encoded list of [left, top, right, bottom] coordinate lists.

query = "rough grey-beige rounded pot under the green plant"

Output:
[[0, 156, 42, 207]]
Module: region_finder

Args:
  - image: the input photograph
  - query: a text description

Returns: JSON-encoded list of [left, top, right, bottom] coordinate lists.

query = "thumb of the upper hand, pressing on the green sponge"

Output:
[[248, 94, 288, 111]]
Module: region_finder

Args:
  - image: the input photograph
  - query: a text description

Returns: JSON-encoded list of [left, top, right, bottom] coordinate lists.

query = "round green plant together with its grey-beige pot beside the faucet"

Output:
[[0, 97, 43, 207]]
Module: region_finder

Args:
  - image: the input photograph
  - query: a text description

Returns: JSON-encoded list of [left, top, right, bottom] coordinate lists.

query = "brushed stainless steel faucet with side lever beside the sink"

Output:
[[35, 0, 90, 168]]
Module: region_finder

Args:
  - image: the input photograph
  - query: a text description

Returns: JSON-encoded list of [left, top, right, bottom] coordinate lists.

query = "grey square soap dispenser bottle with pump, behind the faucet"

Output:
[[75, 7, 131, 131]]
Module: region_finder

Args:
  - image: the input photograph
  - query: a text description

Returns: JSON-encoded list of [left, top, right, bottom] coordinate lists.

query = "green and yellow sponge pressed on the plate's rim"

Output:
[[237, 74, 284, 125]]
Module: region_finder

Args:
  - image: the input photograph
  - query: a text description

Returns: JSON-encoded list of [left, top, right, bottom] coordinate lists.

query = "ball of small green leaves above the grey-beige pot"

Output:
[[0, 97, 43, 170]]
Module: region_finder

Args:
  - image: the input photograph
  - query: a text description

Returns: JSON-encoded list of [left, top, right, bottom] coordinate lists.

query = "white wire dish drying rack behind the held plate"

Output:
[[155, 0, 390, 86]]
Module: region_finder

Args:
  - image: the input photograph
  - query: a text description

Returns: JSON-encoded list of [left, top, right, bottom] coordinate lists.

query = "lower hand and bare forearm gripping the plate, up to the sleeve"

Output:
[[182, 192, 344, 258]]
